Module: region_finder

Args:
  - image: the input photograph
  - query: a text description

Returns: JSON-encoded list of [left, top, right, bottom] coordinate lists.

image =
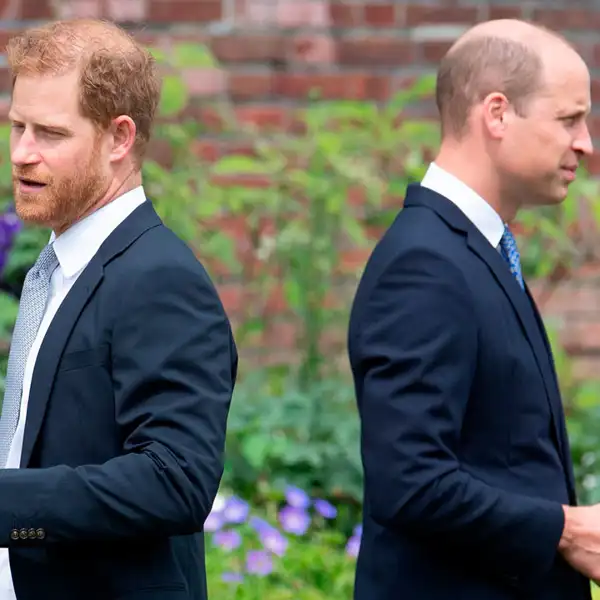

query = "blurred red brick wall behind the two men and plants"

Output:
[[0, 0, 600, 376]]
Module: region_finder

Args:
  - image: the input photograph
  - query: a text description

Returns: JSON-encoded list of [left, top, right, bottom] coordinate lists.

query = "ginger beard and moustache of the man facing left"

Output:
[[13, 144, 108, 233]]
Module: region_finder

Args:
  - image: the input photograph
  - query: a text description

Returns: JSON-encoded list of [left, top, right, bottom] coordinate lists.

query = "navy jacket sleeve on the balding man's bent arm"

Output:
[[353, 250, 564, 580]]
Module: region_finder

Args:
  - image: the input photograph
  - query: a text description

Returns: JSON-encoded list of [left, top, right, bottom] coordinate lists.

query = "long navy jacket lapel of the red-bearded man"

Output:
[[20, 201, 161, 468]]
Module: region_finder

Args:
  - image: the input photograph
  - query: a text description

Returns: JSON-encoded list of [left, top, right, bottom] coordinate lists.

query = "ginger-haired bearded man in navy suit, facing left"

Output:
[[0, 20, 237, 600]]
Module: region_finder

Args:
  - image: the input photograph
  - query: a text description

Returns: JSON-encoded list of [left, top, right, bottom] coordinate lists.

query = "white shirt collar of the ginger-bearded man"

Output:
[[50, 186, 146, 278]]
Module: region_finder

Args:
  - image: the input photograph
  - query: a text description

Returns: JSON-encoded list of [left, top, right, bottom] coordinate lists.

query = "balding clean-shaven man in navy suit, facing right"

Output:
[[349, 21, 600, 600]]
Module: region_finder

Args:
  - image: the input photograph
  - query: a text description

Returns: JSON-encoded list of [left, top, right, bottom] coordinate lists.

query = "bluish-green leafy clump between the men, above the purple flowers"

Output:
[[224, 373, 362, 521]]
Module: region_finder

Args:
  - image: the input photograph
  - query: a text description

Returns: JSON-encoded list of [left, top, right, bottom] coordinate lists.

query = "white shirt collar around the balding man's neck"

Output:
[[421, 163, 504, 248]]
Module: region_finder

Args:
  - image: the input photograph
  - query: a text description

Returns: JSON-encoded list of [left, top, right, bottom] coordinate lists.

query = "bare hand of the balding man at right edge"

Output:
[[558, 504, 600, 581]]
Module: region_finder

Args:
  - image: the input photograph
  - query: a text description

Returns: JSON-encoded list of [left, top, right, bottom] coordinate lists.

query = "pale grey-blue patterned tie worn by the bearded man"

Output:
[[0, 244, 58, 468]]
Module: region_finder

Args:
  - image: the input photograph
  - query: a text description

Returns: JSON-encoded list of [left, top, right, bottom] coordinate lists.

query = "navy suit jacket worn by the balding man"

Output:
[[348, 185, 590, 600]]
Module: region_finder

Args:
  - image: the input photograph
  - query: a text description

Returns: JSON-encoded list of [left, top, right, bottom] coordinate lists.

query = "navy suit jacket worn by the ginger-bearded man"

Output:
[[0, 202, 237, 600]]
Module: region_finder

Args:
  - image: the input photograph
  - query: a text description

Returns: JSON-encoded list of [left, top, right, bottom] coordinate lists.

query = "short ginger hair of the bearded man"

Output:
[[6, 19, 160, 168]]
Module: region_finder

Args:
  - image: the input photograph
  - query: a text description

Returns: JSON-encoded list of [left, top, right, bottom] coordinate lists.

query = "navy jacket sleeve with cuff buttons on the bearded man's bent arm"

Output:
[[0, 258, 237, 546]]
